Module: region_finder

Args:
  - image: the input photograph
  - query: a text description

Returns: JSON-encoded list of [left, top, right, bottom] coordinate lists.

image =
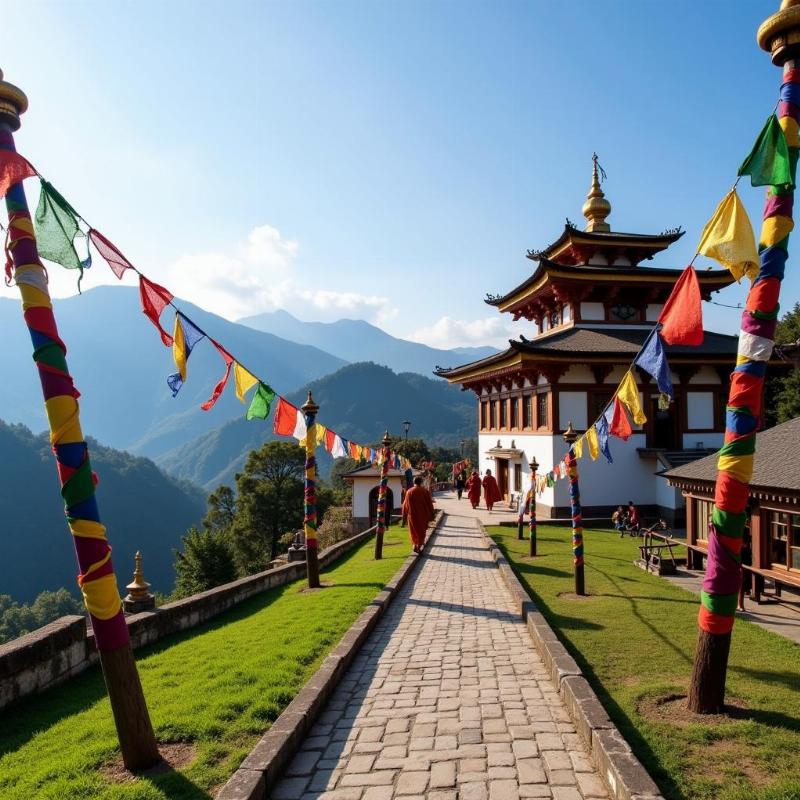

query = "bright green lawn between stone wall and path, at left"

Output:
[[0, 527, 410, 800]]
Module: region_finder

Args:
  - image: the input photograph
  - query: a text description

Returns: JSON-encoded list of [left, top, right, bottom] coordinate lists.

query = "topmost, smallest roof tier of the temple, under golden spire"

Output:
[[528, 220, 685, 265]]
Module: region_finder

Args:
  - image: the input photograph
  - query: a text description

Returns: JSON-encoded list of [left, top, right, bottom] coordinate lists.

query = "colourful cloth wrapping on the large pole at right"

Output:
[[698, 62, 800, 634]]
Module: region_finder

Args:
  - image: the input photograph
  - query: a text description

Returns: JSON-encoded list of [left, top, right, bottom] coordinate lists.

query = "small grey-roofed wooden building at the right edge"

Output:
[[662, 417, 800, 589]]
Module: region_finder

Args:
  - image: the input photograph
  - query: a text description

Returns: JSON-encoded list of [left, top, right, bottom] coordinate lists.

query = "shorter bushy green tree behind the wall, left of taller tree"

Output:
[[173, 528, 236, 598]]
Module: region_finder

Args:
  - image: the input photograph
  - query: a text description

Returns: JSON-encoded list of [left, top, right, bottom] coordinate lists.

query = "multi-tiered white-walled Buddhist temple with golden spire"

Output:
[[437, 156, 737, 523]]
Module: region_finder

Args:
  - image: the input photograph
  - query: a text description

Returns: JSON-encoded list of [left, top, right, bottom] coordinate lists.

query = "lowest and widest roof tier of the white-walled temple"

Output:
[[436, 326, 739, 388]]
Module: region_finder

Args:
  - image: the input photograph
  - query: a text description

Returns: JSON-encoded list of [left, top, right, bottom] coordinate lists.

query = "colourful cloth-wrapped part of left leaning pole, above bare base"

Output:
[[0, 127, 129, 651]]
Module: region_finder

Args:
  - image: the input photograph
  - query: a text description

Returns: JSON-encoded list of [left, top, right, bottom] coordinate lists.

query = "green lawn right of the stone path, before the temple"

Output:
[[489, 526, 800, 800]]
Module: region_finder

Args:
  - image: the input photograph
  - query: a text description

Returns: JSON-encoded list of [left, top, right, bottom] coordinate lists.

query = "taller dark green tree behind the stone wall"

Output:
[[231, 442, 306, 575]]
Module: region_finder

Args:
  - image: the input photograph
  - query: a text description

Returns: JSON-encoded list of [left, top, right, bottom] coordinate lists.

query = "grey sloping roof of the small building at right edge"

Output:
[[662, 417, 800, 493]]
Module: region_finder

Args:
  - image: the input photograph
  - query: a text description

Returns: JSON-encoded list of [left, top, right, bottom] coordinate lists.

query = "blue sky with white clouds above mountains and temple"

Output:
[[0, 0, 800, 347]]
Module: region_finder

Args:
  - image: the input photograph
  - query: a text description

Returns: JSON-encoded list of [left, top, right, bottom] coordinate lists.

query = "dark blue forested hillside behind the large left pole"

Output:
[[0, 421, 205, 602]]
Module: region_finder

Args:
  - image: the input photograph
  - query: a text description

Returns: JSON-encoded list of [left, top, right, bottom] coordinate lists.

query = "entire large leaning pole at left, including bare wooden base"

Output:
[[0, 72, 161, 770]]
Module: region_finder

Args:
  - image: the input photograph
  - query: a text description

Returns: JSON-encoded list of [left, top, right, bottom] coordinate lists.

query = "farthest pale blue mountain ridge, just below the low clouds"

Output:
[[239, 311, 497, 376]]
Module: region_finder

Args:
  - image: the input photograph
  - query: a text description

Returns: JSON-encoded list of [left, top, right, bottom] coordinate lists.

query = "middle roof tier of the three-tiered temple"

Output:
[[485, 256, 734, 319]]
